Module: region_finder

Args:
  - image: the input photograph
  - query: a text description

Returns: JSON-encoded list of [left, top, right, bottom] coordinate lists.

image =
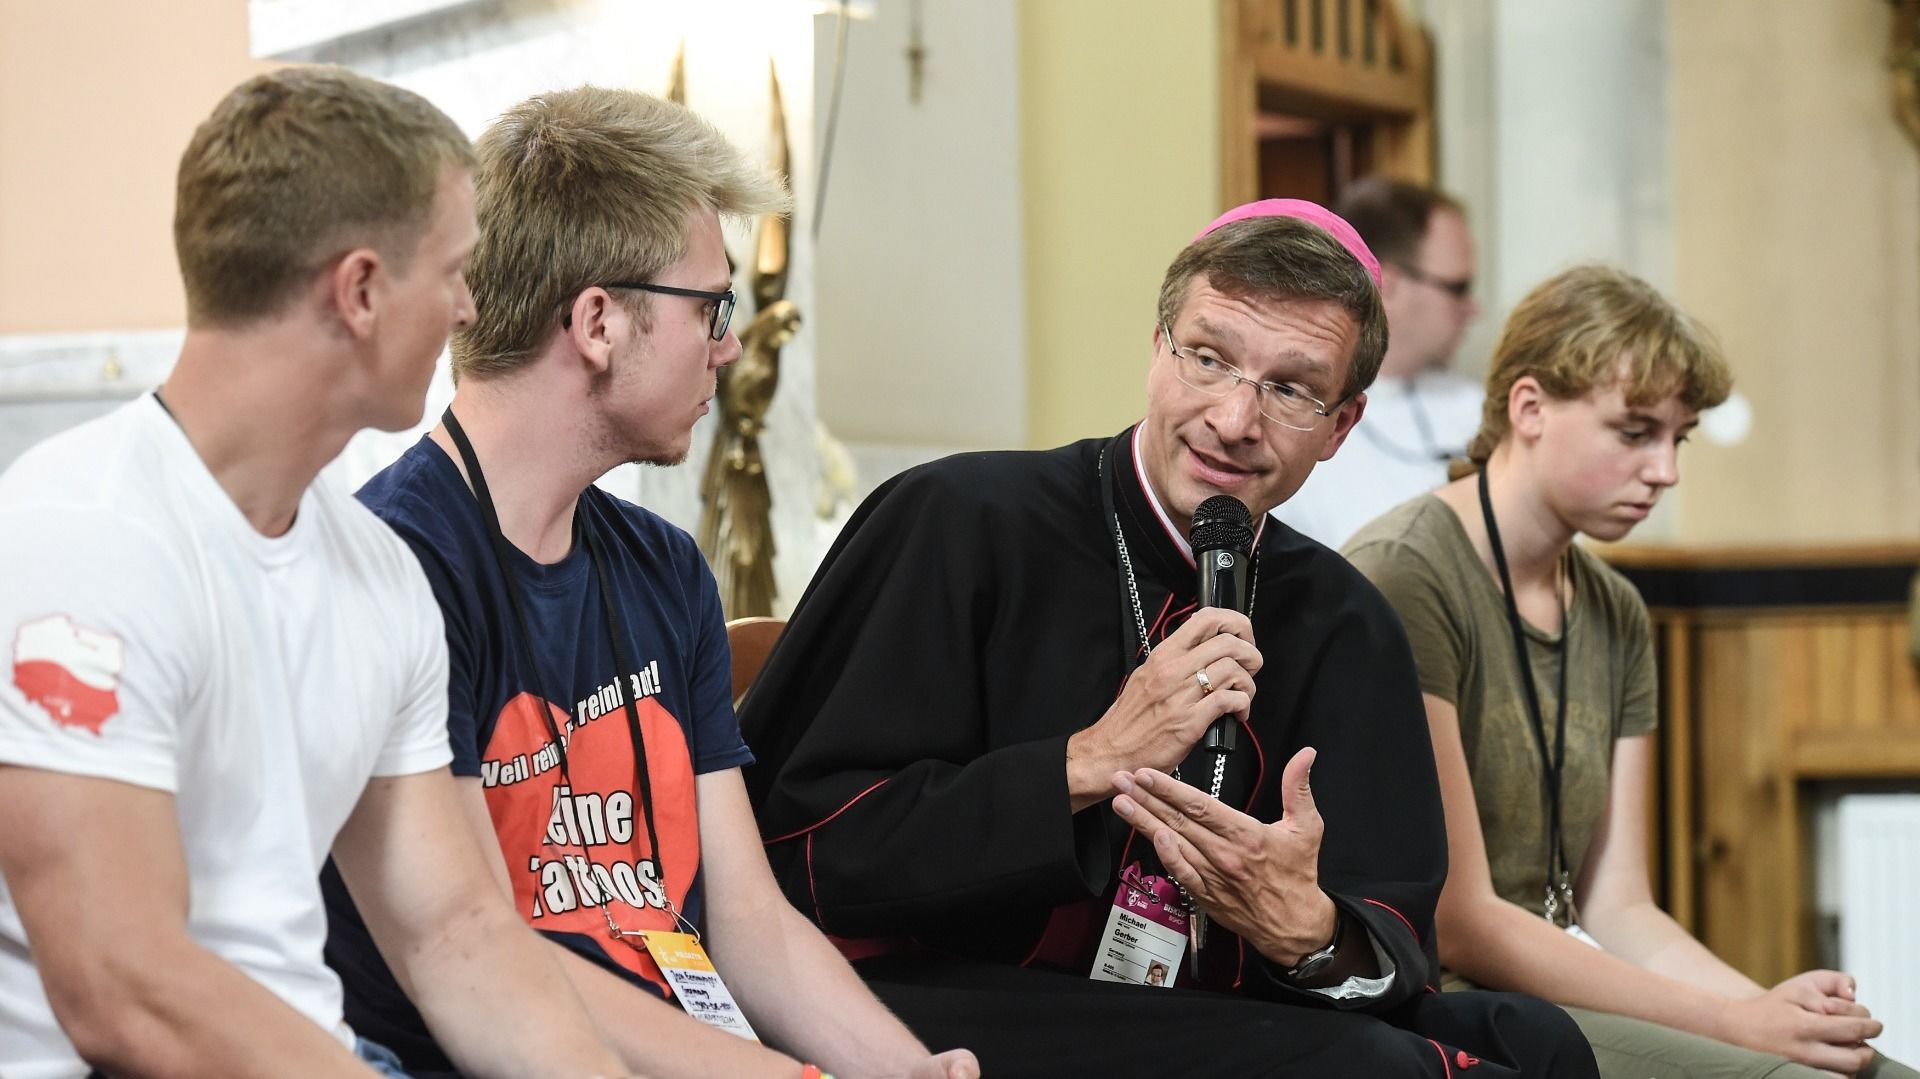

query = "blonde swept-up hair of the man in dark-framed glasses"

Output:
[[453, 86, 787, 378]]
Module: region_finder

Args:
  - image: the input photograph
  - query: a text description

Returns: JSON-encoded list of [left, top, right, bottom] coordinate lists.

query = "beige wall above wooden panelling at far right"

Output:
[[1670, 0, 1920, 545]]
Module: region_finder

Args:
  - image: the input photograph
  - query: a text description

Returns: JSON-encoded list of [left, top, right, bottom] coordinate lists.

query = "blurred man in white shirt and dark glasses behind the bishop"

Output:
[[1273, 177, 1484, 549]]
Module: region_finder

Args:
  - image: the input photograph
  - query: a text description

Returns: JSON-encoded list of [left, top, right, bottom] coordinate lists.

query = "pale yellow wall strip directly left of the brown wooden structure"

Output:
[[1020, 0, 1219, 445]]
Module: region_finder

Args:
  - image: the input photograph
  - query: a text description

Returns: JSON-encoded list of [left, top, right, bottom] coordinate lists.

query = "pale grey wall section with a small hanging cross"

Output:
[[804, 0, 1027, 447]]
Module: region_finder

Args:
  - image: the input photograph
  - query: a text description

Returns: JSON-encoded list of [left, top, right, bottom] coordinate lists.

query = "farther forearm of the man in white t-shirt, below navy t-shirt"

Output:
[[388, 893, 622, 1077]]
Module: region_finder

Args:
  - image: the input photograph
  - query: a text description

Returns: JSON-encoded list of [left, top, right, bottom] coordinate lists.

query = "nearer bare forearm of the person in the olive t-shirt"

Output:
[[1438, 897, 1726, 1039]]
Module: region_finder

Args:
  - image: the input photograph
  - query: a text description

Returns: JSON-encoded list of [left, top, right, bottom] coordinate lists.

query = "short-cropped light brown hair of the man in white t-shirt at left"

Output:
[[173, 67, 474, 326]]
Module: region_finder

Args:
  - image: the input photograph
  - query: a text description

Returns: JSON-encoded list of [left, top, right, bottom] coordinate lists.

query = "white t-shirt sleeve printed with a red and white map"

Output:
[[0, 503, 205, 793]]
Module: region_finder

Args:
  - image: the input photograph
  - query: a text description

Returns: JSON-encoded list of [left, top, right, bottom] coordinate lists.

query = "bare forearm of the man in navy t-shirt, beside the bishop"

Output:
[[714, 902, 927, 1079]]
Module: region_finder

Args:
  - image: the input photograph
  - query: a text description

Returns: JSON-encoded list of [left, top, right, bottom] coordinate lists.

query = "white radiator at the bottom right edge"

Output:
[[1836, 795, 1920, 1066]]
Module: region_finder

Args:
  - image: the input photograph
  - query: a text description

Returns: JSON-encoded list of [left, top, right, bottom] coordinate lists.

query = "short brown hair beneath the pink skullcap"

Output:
[[1160, 217, 1386, 403]]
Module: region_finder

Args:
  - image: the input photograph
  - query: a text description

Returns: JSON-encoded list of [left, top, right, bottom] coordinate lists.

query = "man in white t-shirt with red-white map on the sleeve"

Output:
[[0, 67, 618, 1079]]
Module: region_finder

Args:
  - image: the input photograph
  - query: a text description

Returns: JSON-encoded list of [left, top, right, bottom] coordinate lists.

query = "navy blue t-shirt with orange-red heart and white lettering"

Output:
[[323, 438, 753, 1073]]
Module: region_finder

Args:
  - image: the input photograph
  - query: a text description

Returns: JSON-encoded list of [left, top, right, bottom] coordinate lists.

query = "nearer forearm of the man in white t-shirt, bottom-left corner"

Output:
[[50, 941, 369, 1079]]
